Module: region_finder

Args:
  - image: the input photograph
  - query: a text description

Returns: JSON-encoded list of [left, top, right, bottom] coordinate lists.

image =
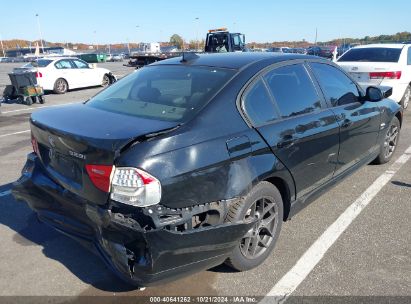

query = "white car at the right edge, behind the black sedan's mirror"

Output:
[[337, 43, 411, 109]]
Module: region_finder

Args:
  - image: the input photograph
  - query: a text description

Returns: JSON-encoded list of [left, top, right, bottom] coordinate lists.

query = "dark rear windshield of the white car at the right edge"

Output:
[[338, 48, 401, 62]]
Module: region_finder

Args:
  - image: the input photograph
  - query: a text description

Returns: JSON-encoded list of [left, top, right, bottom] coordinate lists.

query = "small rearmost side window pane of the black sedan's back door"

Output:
[[243, 79, 278, 126]]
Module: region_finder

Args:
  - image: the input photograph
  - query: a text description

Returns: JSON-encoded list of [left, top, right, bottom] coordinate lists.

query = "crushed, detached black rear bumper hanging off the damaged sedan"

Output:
[[12, 154, 253, 286]]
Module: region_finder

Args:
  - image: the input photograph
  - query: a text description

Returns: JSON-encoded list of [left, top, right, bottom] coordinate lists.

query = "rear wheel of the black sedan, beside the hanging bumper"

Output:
[[225, 181, 284, 271]]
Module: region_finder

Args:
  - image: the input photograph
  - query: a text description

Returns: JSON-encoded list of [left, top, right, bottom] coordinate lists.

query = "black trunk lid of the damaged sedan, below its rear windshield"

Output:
[[30, 104, 178, 204]]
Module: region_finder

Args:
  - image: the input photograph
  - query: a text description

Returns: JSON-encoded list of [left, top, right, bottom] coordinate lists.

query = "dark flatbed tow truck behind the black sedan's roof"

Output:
[[125, 28, 245, 69]]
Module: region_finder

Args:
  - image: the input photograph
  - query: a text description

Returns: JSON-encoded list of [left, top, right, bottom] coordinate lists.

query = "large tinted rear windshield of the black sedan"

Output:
[[86, 65, 236, 123]]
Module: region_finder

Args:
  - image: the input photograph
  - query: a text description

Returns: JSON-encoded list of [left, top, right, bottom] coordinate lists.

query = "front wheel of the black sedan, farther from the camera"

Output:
[[374, 116, 401, 165]]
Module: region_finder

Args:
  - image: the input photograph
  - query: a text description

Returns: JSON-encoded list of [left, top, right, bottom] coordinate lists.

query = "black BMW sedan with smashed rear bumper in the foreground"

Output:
[[13, 53, 402, 286]]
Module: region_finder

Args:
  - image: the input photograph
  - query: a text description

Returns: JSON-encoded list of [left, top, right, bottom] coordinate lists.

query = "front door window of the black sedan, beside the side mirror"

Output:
[[310, 63, 360, 107]]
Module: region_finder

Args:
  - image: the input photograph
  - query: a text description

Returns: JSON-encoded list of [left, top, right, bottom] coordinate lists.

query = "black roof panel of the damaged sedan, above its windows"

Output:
[[151, 52, 318, 69]]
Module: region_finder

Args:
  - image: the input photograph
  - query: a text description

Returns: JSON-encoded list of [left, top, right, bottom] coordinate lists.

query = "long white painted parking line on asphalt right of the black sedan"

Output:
[[260, 146, 411, 304]]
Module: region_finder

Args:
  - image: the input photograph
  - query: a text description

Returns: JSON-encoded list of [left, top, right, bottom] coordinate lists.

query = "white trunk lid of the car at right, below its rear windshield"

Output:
[[338, 62, 401, 86]]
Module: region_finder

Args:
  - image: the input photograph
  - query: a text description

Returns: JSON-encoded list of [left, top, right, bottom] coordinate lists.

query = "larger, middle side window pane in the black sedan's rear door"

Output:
[[264, 64, 321, 118]]
